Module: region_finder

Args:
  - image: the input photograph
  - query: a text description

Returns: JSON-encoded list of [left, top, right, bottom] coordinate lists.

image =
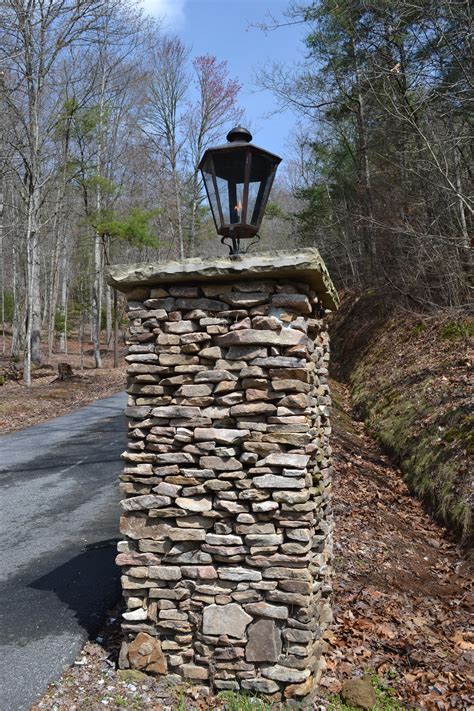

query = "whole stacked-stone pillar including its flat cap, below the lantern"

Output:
[[109, 250, 337, 702]]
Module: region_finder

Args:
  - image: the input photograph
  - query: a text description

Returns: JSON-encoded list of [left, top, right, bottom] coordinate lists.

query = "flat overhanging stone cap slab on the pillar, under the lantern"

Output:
[[107, 248, 339, 310]]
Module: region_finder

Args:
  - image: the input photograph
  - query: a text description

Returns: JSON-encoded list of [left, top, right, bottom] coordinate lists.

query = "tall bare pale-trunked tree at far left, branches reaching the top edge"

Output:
[[0, 0, 110, 385]]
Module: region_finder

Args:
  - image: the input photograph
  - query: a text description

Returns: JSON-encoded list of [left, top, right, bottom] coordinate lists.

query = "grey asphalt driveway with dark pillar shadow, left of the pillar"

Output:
[[0, 393, 126, 711]]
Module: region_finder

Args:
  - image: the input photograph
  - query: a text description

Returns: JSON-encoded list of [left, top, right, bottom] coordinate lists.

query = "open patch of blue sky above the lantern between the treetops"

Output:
[[142, 0, 304, 159]]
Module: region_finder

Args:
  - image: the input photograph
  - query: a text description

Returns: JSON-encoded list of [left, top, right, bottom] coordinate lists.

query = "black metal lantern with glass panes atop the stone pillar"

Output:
[[199, 126, 281, 256]]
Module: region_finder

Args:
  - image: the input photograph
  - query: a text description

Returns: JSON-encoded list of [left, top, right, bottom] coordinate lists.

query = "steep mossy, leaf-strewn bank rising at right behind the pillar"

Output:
[[331, 293, 474, 542]]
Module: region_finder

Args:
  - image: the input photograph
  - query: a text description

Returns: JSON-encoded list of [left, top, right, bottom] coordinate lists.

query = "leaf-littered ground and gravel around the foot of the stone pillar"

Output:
[[32, 382, 474, 711]]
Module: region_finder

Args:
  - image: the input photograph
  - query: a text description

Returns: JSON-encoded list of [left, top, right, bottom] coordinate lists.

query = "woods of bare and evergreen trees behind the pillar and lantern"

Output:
[[0, 0, 474, 384]]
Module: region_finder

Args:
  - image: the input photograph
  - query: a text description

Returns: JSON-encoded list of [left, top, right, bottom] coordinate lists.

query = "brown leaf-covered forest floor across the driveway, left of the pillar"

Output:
[[0, 338, 126, 434]]
